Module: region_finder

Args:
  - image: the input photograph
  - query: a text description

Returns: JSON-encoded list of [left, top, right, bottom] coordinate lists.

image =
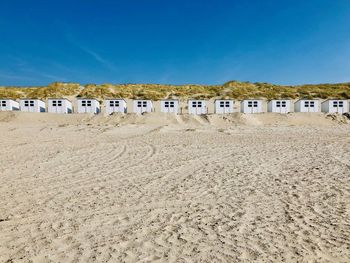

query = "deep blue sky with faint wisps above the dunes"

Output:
[[0, 0, 350, 86]]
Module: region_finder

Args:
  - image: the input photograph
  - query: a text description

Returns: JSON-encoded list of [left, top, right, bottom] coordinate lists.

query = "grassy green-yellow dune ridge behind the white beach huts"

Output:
[[0, 81, 350, 100]]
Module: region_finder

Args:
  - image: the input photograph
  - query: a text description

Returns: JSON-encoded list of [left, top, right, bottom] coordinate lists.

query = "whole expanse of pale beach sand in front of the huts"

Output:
[[0, 113, 350, 262]]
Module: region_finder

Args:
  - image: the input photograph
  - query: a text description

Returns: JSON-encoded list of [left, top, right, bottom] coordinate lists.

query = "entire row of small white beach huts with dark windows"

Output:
[[0, 98, 349, 115]]
